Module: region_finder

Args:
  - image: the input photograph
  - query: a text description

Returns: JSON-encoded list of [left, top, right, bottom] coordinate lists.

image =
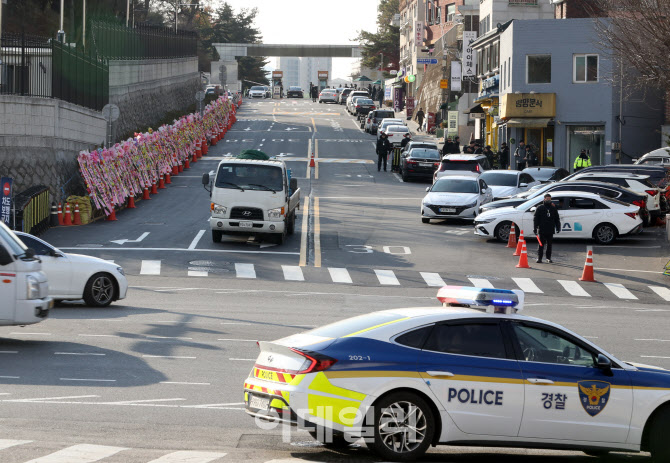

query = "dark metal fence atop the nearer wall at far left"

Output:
[[0, 33, 109, 111]]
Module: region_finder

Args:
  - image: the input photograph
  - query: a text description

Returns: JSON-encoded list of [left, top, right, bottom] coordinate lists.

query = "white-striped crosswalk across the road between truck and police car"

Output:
[[130, 260, 670, 303]]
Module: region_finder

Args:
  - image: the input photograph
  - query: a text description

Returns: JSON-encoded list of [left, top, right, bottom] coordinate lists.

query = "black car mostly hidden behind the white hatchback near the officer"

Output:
[[482, 180, 649, 224]]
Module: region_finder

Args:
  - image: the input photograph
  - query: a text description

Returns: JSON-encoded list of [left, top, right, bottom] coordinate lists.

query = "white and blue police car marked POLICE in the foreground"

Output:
[[244, 286, 670, 462]]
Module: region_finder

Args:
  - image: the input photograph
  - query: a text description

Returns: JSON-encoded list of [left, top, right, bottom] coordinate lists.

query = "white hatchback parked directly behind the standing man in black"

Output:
[[475, 191, 642, 244]]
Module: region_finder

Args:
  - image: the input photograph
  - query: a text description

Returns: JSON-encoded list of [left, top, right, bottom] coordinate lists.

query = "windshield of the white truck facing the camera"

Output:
[[215, 164, 284, 191]]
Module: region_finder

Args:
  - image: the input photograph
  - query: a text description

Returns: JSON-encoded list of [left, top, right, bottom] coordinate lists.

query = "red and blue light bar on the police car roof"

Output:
[[437, 286, 525, 314]]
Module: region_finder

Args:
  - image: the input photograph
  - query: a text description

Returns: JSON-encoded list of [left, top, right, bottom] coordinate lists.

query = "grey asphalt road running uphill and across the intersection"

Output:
[[0, 96, 670, 463]]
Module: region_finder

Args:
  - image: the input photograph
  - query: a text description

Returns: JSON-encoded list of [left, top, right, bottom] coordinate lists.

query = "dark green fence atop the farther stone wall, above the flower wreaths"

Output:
[[91, 21, 198, 60]]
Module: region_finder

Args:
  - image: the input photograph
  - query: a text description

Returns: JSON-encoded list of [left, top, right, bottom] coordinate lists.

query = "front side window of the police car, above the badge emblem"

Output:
[[512, 323, 596, 367]]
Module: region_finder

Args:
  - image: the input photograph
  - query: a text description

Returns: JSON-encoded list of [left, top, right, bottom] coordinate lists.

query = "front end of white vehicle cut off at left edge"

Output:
[[0, 222, 53, 326]]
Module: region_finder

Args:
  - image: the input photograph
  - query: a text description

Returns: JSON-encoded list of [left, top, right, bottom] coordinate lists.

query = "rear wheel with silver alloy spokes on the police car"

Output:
[[368, 392, 435, 461]]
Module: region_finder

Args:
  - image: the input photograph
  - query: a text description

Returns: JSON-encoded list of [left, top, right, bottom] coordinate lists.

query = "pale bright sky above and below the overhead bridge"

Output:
[[213, 0, 384, 79]]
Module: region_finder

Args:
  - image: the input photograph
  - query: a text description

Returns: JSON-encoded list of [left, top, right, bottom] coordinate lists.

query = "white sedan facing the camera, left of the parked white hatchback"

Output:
[[421, 175, 493, 223]]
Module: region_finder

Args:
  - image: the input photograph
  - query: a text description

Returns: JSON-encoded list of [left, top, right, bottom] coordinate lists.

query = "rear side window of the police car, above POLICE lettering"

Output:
[[424, 323, 507, 358]]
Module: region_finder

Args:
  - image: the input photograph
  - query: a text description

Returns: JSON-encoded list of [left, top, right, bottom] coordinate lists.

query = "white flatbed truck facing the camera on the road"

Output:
[[202, 158, 300, 244]]
